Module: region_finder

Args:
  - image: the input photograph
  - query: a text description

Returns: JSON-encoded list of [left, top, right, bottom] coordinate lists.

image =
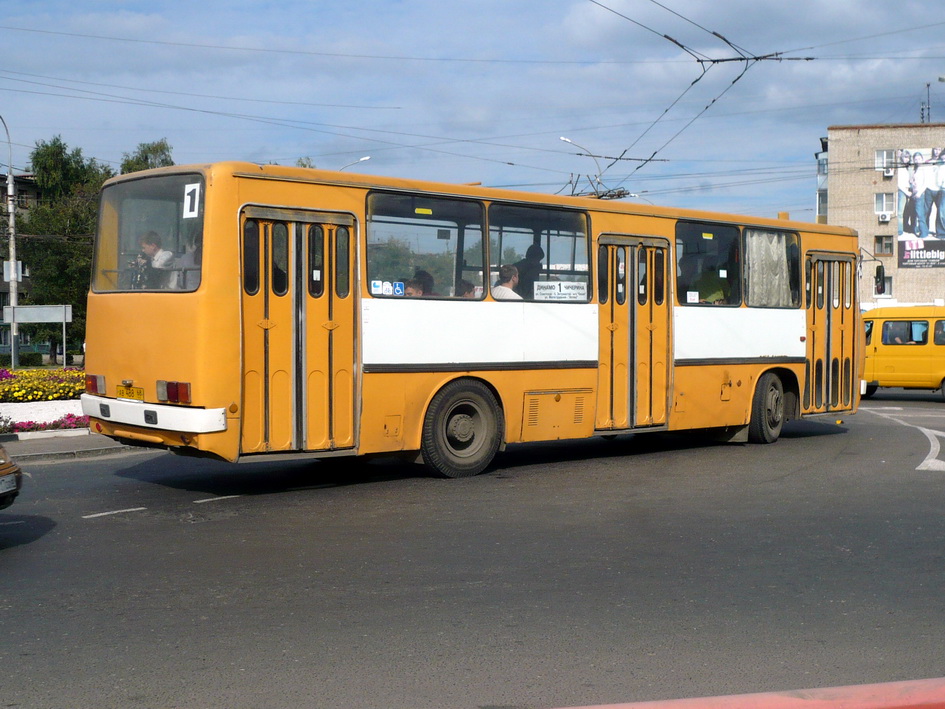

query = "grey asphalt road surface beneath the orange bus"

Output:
[[0, 391, 945, 709]]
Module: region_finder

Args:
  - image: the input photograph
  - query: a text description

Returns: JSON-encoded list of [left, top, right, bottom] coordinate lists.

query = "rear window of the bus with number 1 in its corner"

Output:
[[92, 174, 204, 293]]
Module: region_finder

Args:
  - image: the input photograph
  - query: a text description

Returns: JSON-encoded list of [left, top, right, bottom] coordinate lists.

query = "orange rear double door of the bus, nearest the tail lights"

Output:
[[241, 207, 355, 453]]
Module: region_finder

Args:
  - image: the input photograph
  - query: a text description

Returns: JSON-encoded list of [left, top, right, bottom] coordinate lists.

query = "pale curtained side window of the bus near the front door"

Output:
[[745, 229, 799, 308]]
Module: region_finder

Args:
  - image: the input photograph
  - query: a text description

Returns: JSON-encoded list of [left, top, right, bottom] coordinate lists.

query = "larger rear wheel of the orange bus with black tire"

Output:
[[420, 379, 503, 478]]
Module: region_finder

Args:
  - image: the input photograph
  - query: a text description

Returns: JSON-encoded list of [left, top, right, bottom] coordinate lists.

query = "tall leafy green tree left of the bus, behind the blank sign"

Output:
[[17, 136, 115, 354]]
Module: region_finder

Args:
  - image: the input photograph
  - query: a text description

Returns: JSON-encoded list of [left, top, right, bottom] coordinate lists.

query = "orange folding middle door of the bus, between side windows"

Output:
[[596, 236, 671, 430]]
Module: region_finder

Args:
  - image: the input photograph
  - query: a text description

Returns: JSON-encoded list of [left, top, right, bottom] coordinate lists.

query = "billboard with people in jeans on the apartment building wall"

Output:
[[896, 148, 945, 268]]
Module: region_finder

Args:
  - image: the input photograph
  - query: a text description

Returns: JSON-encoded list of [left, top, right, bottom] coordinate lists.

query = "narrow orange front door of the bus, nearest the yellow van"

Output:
[[803, 252, 859, 414]]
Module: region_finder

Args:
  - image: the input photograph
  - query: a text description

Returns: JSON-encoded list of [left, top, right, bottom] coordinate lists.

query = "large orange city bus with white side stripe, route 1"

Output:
[[82, 162, 862, 477]]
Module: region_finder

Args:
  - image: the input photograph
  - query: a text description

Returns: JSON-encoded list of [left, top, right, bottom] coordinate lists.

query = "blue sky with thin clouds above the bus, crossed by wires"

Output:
[[0, 0, 945, 221]]
